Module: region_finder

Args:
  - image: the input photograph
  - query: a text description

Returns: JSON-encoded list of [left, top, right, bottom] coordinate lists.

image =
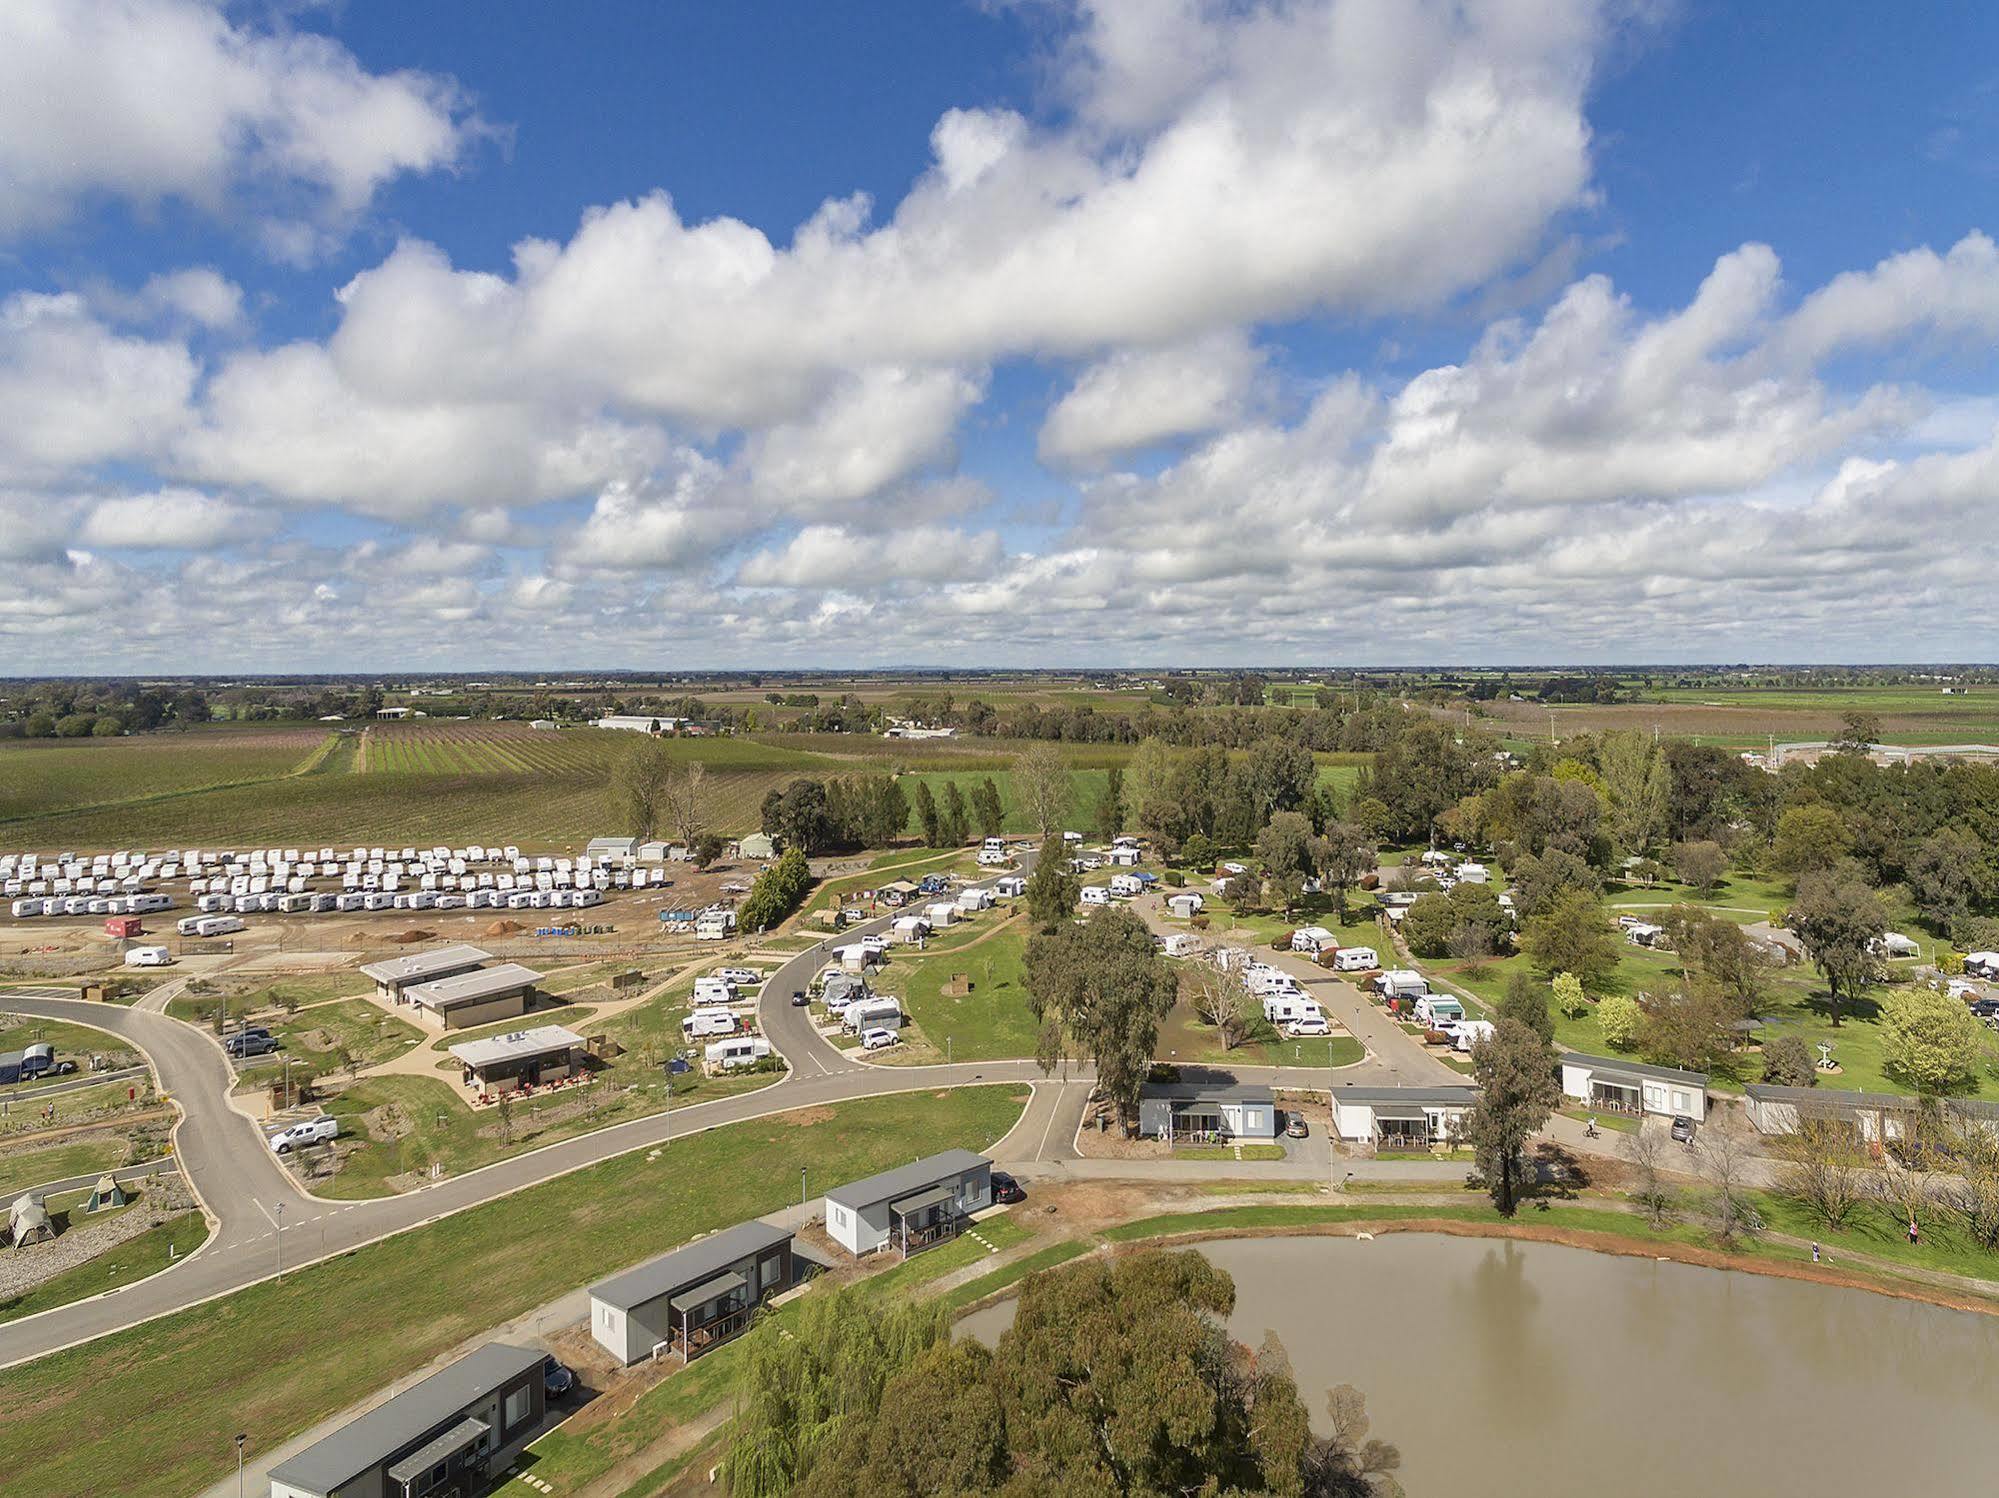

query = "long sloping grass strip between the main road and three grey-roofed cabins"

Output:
[[0, 1088, 1025, 1498]]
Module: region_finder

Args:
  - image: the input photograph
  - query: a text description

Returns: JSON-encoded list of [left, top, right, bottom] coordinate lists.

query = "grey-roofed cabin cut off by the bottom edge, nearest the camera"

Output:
[[270, 1342, 548, 1498]]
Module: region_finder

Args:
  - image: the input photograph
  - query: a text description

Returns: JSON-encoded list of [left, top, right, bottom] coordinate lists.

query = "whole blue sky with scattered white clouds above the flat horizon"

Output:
[[0, 0, 1999, 672]]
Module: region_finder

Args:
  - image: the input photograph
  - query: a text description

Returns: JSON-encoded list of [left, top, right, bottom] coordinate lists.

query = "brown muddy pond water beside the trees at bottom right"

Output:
[[964, 1234, 1999, 1498]]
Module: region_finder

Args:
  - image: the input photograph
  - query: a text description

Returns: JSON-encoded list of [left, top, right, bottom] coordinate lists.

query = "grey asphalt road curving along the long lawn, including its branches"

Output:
[[0, 856, 1439, 1368]]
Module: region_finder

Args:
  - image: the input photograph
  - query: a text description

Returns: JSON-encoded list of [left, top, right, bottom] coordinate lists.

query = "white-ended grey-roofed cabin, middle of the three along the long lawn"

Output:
[[590, 1222, 796, 1364]]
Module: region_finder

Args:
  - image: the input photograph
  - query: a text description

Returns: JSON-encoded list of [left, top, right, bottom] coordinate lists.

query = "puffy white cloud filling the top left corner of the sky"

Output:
[[0, 0, 480, 258]]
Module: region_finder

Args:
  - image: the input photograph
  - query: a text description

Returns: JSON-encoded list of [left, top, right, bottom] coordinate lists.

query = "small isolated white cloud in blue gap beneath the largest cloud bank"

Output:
[[1039, 330, 1263, 468]]
